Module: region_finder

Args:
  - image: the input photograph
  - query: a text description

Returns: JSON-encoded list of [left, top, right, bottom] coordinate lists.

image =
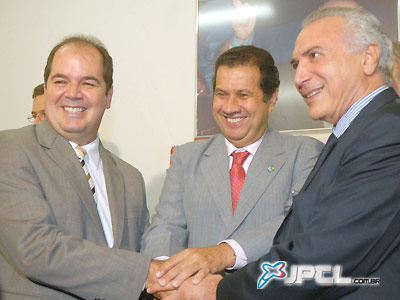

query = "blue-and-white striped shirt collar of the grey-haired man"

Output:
[[332, 86, 388, 138]]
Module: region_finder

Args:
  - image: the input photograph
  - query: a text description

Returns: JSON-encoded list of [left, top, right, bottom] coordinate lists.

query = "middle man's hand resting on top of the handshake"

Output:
[[156, 243, 236, 288]]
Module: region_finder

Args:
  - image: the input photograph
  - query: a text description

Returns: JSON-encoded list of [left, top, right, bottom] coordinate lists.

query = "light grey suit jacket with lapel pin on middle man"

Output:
[[141, 131, 322, 261]]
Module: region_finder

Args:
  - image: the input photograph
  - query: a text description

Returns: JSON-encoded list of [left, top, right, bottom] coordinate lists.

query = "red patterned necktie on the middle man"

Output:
[[230, 151, 250, 214]]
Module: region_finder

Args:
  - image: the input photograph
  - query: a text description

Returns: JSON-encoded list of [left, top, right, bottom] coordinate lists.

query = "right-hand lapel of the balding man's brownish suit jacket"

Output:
[[100, 143, 125, 248]]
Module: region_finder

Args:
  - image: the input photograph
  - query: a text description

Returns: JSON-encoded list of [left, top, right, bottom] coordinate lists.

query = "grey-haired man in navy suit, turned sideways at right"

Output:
[[161, 7, 400, 300]]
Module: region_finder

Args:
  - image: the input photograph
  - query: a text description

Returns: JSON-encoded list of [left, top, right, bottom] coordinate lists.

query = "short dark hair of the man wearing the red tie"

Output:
[[213, 46, 280, 102]]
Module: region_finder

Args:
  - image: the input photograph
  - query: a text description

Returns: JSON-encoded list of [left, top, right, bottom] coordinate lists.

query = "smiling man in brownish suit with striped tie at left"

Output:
[[0, 36, 150, 300]]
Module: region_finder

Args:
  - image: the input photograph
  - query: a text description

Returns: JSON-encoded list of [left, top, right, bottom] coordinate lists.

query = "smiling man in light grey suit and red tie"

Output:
[[141, 46, 322, 292]]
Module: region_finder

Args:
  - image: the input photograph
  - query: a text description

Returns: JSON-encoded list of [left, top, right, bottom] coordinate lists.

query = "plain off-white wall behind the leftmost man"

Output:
[[0, 0, 197, 216]]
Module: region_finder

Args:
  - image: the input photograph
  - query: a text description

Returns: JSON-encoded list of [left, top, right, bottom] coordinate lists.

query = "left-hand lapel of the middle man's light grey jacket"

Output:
[[200, 134, 232, 226]]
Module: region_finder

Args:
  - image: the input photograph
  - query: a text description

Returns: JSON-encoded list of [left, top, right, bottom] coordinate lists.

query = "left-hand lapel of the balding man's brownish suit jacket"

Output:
[[36, 120, 105, 237]]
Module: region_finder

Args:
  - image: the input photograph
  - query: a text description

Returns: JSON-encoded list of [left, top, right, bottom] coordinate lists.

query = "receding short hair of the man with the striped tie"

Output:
[[44, 35, 113, 94]]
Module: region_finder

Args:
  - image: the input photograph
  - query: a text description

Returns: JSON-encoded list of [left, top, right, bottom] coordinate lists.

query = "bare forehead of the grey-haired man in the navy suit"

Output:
[[293, 16, 346, 56]]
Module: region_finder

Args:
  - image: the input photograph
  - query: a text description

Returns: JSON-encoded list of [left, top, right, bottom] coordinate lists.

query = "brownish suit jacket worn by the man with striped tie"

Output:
[[0, 121, 150, 300]]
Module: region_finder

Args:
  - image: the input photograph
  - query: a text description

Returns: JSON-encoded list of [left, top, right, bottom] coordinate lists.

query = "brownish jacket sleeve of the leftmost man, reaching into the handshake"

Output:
[[0, 133, 150, 299]]
